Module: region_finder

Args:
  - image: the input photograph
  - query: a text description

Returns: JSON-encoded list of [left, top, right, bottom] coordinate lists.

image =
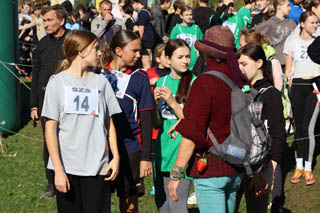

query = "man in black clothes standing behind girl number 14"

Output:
[[30, 5, 67, 198]]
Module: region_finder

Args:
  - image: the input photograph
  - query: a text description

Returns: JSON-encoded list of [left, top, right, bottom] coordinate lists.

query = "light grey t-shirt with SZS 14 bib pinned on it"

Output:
[[42, 71, 121, 176]]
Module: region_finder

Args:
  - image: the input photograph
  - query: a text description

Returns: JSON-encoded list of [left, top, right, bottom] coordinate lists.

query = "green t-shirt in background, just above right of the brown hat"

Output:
[[222, 7, 251, 49]]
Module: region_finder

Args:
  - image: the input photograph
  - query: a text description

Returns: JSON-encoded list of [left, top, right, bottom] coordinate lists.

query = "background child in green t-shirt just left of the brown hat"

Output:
[[170, 6, 203, 70]]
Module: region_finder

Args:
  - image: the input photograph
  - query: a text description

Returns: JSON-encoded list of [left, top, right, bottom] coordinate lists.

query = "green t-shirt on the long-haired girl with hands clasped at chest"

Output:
[[155, 74, 196, 172]]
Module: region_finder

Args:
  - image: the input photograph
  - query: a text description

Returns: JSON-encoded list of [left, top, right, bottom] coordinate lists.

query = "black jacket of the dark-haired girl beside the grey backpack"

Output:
[[253, 78, 286, 163]]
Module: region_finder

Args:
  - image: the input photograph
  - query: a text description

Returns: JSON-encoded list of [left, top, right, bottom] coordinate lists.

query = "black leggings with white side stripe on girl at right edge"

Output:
[[290, 78, 320, 162]]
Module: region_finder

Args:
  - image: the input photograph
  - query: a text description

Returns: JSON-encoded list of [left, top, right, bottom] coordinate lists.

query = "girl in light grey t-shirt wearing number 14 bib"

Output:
[[42, 30, 121, 212]]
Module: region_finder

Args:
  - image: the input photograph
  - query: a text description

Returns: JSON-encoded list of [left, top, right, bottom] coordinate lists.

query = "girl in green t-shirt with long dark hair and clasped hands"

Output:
[[153, 39, 196, 213]]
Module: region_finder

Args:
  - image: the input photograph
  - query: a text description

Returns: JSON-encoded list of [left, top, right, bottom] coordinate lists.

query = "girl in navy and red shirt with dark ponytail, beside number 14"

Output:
[[100, 30, 154, 212]]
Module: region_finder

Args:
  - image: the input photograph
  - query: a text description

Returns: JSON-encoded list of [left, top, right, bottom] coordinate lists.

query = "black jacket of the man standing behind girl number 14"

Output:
[[31, 31, 67, 108]]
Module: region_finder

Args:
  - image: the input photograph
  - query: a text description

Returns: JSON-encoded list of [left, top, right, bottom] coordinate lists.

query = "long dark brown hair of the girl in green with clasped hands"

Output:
[[164, 39, 192, 104]]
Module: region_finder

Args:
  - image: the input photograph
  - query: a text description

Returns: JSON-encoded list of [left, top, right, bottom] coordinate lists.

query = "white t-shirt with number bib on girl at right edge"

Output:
[[283, 33, 320, 79]]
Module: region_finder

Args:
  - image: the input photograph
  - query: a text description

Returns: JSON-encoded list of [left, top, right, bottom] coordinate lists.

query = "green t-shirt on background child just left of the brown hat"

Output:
[[170, 24, 203, 70]]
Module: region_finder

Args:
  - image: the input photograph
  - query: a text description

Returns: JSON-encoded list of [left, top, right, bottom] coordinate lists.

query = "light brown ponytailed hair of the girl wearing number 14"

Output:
[[56, 30, 97, 74]]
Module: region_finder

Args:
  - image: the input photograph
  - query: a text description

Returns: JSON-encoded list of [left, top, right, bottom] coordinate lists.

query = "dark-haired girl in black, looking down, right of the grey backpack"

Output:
[[235, 43, 286, 213]]
